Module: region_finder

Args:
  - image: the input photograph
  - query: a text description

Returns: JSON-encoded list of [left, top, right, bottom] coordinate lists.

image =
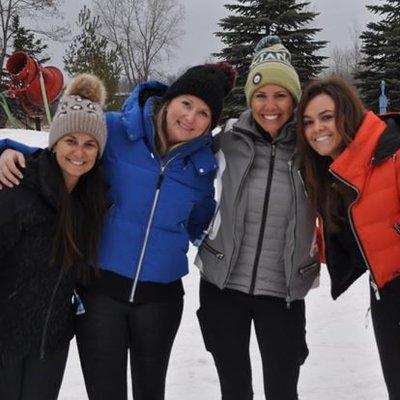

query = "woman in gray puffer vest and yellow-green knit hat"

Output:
[[196, 36, 319, 400]]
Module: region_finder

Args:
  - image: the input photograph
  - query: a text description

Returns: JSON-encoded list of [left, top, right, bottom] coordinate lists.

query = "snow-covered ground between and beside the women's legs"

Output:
[[59, 255, 387, 400]]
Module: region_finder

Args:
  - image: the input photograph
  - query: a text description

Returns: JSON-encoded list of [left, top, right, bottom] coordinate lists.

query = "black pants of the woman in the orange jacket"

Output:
[[371, 278, 400, 400]]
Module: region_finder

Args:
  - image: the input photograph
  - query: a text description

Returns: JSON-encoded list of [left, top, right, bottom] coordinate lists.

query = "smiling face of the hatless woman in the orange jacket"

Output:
[[303, 94, 344, 159]]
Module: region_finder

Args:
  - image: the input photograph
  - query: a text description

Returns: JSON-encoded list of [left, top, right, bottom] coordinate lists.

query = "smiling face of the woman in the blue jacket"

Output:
[[166, 95, 211, 145]]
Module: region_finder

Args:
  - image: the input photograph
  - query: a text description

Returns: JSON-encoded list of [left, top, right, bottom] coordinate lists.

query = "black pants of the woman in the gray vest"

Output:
[[197, 280, 308, 400]]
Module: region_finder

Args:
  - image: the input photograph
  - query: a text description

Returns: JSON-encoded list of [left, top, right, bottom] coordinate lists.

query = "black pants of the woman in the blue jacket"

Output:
[[76, 294, 183, 400]]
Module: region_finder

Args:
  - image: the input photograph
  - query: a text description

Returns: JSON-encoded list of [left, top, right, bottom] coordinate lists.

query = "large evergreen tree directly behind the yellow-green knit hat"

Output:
[[214, 0, 327, 118]]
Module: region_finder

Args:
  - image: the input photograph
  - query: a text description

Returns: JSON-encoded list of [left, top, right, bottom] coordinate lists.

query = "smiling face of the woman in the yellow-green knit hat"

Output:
[[250, 84, 294, 137]]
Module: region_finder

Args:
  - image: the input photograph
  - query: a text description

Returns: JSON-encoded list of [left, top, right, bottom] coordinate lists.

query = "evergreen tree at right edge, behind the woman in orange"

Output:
[[355, 0, 400, 111]]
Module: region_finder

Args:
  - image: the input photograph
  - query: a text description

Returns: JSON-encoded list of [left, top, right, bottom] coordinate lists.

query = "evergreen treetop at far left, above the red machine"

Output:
[[12, 15, 50, 64]]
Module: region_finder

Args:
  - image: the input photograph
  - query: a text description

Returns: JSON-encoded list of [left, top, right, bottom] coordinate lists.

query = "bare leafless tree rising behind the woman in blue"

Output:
[[93, 0, 184, 87]]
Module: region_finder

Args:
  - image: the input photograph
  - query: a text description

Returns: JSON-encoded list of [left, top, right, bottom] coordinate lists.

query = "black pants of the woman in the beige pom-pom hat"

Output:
[[0, 346, 69, 400]]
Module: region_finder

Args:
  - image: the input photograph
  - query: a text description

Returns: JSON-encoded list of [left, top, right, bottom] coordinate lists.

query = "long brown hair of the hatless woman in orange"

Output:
[[297, 76, 366, 230]]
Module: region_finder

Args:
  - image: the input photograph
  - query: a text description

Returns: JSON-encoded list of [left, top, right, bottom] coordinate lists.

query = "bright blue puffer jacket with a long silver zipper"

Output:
[[0, 81, 217, 300]]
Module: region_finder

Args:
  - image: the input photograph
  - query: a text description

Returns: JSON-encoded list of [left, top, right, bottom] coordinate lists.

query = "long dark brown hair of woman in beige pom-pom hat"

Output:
[[51, 153, 106, 283]]
